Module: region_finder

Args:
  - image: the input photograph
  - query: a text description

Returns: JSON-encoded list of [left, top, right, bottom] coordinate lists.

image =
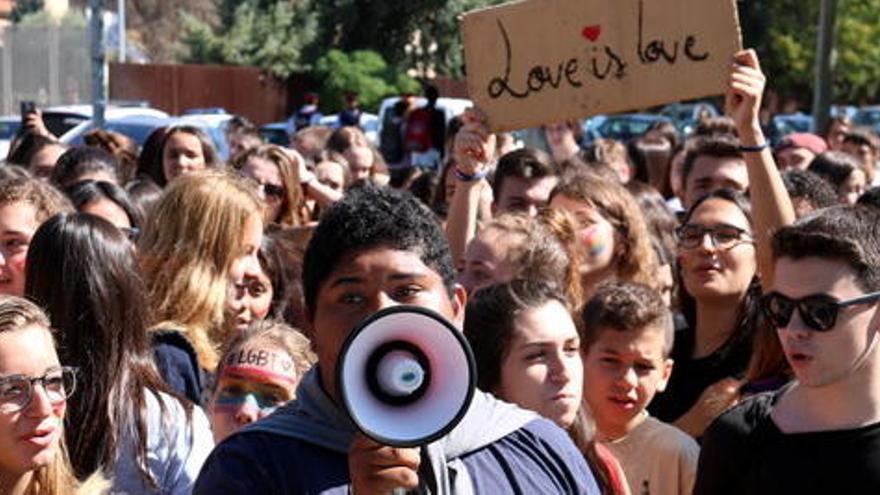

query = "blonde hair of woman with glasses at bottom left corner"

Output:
[[0, 295, 78, 495]]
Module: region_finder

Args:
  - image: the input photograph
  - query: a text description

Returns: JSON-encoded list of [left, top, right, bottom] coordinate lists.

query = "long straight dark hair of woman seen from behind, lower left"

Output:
[[25, 213, 192, 488]]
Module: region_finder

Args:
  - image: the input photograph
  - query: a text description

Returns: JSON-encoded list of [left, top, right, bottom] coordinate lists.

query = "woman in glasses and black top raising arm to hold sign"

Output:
[[649, 50, 794, 437]]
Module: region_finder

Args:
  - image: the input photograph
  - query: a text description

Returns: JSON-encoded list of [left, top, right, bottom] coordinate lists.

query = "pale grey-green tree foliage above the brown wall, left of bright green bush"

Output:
[[184, 0, 318, 78]]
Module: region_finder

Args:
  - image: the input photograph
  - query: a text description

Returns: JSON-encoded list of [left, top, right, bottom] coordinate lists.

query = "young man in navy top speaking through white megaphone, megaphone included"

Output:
[[195, 186, 599, 495]]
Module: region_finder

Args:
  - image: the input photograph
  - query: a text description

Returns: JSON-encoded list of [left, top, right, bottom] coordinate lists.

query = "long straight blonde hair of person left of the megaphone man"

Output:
[[138, 171, 262, 370]]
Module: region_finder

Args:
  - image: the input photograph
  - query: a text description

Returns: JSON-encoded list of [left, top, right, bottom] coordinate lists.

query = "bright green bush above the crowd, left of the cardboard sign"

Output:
[[314, 49, 420, 110]]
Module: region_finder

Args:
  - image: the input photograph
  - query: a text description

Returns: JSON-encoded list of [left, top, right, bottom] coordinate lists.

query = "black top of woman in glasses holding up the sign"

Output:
[[648, 318, 754, 423]]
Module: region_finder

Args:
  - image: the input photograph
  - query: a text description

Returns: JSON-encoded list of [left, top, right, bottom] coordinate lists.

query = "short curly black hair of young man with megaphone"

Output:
[[303, 184, 455, 314]]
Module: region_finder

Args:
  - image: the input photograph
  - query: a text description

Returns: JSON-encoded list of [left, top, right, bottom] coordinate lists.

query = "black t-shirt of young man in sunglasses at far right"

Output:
[[694, 391, 880, 495]]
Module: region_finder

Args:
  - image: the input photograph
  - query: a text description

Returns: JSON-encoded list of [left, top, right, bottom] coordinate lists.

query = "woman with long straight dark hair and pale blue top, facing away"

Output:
[[25, 213, 213, 494]]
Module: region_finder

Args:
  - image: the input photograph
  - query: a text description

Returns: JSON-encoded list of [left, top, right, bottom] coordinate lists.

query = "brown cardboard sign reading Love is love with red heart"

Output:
[[461, 0, 742, 131]]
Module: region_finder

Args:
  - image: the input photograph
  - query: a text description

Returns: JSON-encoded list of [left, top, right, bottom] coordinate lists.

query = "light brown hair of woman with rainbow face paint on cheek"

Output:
[[550, 174, 657, 288]]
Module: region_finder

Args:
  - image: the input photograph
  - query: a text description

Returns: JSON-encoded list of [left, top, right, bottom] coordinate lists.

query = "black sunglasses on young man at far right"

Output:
[[761, 292, 880, 332]]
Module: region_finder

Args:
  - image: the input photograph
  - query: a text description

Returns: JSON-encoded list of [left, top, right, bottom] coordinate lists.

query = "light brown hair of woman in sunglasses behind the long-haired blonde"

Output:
[[232, 144, 307, 227]]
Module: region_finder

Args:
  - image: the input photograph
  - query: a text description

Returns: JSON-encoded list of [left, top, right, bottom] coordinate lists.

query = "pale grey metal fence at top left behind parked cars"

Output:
[[0, 26, 91, 115]]
